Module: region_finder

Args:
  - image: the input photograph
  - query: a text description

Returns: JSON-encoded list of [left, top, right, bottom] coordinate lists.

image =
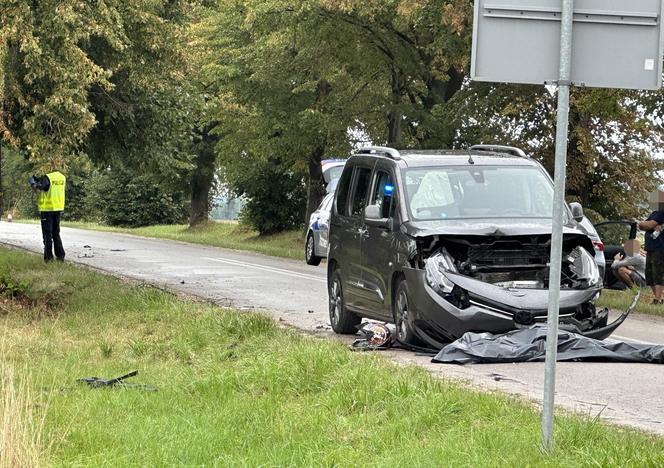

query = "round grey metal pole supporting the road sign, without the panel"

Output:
[[542, 0, 574, 450]]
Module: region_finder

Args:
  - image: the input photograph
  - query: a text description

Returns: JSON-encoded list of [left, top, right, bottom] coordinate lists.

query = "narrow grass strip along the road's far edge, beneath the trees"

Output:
[[22, 220, 304, 260]]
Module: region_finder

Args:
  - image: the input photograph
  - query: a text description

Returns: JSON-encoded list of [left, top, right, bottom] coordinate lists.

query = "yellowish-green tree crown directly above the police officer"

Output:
[[0, 0, 117, 167]]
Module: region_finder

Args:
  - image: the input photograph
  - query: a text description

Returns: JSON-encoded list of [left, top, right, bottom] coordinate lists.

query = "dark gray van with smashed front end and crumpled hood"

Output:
[[327, 145, 626, 347]]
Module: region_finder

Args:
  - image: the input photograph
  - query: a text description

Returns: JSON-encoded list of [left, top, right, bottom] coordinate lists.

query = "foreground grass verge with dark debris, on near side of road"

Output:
[[0, 249, 664, 467]]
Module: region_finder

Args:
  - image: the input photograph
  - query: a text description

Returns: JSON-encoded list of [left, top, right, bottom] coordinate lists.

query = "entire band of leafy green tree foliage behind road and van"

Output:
[[0, 0, 664, 232]]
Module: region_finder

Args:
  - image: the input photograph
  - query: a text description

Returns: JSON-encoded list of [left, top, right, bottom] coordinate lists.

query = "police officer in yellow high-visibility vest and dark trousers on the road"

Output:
[[29, 171, 67, 262]]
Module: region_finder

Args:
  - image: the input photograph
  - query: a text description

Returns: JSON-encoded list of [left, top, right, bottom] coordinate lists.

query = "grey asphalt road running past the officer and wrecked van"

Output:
[[0, 222, 664, 435]]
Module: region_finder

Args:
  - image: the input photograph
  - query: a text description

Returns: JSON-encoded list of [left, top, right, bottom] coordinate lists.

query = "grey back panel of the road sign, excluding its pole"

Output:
[[471, 0, 664, 89]]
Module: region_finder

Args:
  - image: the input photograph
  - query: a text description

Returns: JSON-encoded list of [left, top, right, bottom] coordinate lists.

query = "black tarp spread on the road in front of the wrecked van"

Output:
[[432, 327, 664, 364]]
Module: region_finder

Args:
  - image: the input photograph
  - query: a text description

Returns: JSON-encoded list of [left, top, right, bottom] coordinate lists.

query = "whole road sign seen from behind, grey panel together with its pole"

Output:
[[470, 0, 664, 450]]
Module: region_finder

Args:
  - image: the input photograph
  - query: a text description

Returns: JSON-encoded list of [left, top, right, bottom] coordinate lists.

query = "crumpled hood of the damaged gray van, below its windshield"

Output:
[[403, 218, 586, 237]]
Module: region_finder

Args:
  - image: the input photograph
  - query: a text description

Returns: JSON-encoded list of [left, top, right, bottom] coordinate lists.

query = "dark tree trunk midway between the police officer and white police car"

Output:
[[189, 130, 216, 227]]
